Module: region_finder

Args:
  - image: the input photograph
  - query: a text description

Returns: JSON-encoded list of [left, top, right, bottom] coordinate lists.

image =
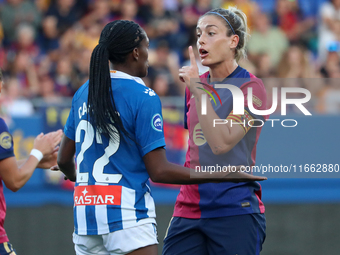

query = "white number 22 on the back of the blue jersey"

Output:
[[76, 120, 123, 183]]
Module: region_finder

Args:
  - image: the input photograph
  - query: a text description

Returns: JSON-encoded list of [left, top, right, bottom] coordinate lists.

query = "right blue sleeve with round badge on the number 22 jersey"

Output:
[[135, 95, 165, 156]]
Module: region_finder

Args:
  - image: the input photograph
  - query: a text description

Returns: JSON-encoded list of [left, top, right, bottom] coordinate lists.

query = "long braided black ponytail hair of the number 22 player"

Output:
[[87, 20, 146, 141]]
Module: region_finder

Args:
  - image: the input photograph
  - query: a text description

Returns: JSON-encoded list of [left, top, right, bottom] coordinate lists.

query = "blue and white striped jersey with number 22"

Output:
[[64, 71, 165, 235]]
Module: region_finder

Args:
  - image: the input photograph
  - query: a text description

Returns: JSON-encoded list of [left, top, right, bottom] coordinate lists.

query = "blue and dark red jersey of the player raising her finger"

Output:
[[173, 64, 268, 219]]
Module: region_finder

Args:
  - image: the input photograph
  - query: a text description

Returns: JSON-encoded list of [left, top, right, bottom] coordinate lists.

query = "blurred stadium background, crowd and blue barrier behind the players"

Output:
[[0, 0, 340, 255]]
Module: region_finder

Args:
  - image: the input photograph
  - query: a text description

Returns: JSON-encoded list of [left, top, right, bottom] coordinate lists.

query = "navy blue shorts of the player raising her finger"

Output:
[[163, 214, 266, 255]]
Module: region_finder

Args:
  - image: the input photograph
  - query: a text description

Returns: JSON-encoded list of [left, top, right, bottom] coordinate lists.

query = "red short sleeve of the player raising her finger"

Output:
[[241, 78, 269, 121]]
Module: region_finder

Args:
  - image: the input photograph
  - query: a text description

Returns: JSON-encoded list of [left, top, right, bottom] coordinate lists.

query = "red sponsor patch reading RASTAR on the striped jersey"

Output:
[[74, 185, 122, 206]]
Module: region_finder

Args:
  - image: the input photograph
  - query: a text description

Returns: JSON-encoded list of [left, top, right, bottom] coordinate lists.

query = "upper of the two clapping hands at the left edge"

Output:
[[33, 129, 63, 156]]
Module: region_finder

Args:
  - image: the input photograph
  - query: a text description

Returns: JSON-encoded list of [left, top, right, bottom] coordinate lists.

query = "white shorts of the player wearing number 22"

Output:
[[73, 223, 158, 255]]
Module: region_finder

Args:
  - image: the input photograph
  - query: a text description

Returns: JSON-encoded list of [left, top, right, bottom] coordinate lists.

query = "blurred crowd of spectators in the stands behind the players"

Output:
[[0, 0, 340, 116]]
